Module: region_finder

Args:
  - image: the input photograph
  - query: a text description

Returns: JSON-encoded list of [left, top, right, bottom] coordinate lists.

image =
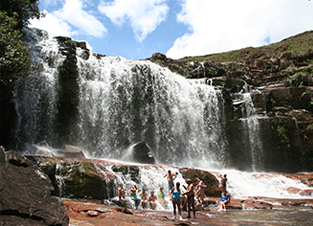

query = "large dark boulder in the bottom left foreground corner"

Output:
[[0, 147, 69, 226]]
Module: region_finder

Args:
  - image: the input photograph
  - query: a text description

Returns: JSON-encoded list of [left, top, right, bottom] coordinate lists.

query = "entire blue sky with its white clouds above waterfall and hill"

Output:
[[30, 0, 313, 60]]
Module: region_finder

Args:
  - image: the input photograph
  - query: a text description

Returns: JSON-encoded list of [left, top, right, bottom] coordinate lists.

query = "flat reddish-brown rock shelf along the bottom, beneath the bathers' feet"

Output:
[[63, 197, 313, 226]]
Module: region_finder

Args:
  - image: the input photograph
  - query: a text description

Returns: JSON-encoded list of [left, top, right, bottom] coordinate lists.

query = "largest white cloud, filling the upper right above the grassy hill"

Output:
[[166, 0, 313, 58]]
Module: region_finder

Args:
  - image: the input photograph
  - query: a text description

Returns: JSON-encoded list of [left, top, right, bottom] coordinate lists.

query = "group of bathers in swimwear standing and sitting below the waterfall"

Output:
[[118, 170, 230, 219]]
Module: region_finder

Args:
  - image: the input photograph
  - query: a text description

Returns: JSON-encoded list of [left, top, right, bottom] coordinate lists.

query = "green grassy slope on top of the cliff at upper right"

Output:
[[181, 31, 313, 62]]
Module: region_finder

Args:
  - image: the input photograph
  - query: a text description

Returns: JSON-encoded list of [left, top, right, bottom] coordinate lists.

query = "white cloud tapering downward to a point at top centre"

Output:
[[98, 0, 169, 42]]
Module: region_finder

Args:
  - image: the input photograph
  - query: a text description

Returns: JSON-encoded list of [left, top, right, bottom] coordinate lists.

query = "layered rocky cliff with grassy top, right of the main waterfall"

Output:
[[148, 31, 313, 172]]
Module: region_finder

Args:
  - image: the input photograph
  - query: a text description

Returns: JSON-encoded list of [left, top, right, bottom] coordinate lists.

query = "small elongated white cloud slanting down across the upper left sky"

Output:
[[53, 0, 107, 38]]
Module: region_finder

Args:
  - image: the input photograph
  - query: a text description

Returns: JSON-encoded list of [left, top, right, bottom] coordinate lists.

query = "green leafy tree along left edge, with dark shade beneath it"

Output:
[[0, 0, 41, 149]]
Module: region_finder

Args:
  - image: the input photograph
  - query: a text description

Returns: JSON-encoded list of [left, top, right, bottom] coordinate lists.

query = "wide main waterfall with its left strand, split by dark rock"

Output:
[[15, 28, 227, 168]]
